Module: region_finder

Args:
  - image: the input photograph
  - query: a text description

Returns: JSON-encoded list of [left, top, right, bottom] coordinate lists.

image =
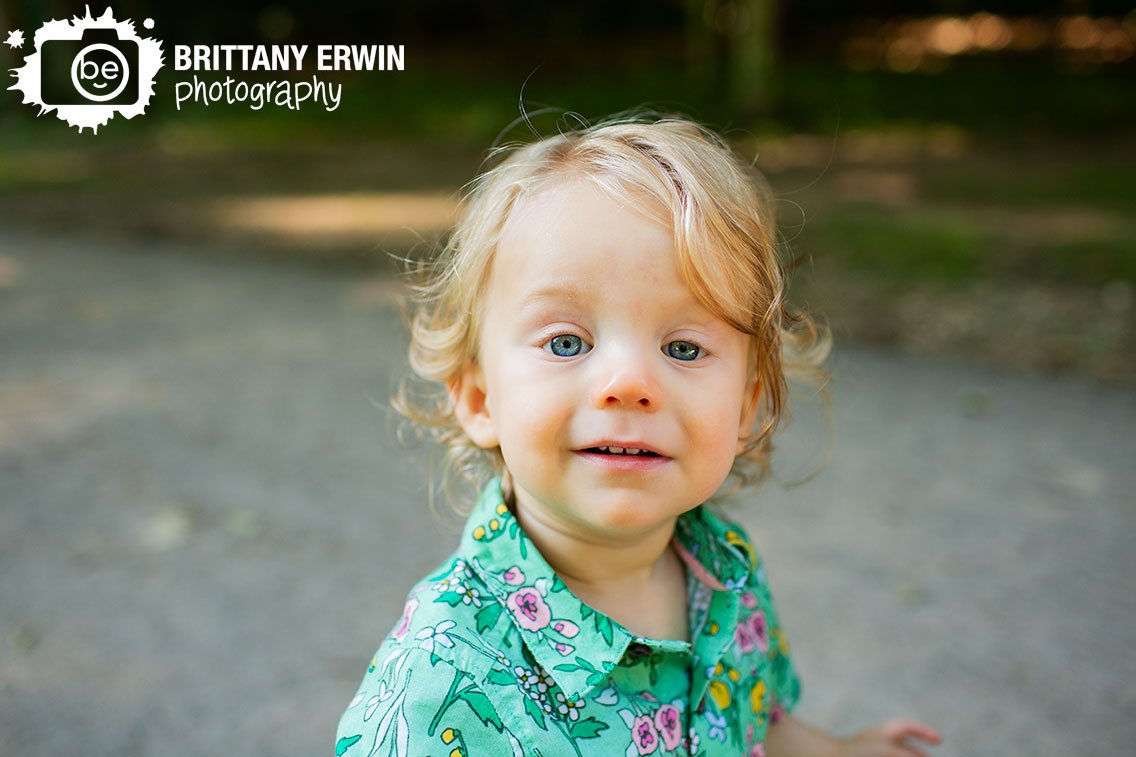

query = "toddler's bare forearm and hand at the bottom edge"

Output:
[[766, 715, 942, 757]]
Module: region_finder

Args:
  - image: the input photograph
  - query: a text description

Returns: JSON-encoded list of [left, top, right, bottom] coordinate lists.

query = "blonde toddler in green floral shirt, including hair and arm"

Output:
[[335, 113, 938, 757]]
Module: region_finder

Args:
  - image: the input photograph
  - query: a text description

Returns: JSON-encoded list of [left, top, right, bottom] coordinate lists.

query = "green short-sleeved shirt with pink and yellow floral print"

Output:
[[335, 481, 800, 757]]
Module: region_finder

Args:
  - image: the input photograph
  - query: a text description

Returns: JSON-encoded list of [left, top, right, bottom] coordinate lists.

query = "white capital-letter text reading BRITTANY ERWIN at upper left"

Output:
[[174, 44, 406, 70]]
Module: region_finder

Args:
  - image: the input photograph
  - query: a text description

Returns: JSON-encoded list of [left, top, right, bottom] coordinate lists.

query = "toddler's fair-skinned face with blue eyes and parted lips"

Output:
[[454, 178, 757, 538]]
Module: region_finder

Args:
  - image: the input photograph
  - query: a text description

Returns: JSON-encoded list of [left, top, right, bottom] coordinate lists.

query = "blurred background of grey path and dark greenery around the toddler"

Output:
[[0, 0, 1136, 755]]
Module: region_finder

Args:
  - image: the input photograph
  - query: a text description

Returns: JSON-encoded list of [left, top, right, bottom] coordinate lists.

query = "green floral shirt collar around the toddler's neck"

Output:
[[461, 479, 754, 698]]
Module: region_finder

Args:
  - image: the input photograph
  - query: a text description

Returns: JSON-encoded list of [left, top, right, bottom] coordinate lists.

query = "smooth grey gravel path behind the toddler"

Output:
[[0, 232, 1136, 757]]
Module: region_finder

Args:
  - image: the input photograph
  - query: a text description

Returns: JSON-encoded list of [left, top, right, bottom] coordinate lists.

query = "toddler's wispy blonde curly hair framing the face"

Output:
[[392, 115, 832, 506]]
